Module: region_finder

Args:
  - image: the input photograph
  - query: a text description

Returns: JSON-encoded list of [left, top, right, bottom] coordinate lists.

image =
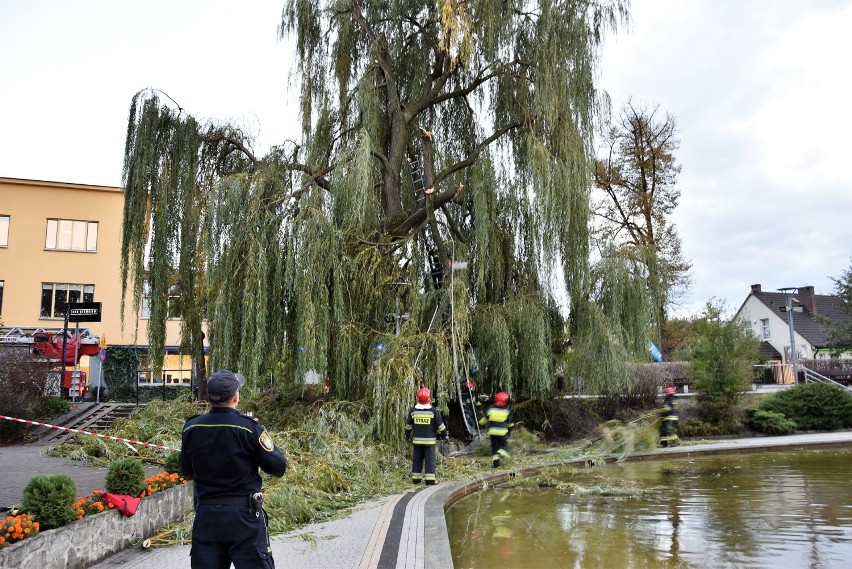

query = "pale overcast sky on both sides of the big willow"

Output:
[[0, 0, 852, 316]]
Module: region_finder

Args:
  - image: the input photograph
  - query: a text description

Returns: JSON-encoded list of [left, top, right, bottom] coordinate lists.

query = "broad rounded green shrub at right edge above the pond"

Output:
[[758, 383, 852, 431]]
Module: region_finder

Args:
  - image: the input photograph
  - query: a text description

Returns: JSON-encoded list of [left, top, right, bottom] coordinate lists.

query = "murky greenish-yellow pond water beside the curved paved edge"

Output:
[[447, 449, 852, 569]]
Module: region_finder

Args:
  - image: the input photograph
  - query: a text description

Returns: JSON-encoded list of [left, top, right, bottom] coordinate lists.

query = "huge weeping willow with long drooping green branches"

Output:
[[123, 0, 627, 442]]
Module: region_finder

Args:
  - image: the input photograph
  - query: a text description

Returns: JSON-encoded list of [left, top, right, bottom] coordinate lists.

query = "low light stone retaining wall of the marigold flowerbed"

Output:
[[0, 482, 192, 569]]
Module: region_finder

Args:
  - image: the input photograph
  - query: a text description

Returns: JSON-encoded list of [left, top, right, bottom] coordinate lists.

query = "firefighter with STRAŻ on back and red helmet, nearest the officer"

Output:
[[405, 387, 449, 484]]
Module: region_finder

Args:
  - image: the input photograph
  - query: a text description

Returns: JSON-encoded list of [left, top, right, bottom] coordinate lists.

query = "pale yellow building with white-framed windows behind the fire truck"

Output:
[[0, 178, 201, 390]]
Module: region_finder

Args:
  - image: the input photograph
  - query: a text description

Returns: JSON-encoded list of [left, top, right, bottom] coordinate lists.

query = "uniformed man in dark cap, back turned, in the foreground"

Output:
[[180, 369, 287, 569]]
